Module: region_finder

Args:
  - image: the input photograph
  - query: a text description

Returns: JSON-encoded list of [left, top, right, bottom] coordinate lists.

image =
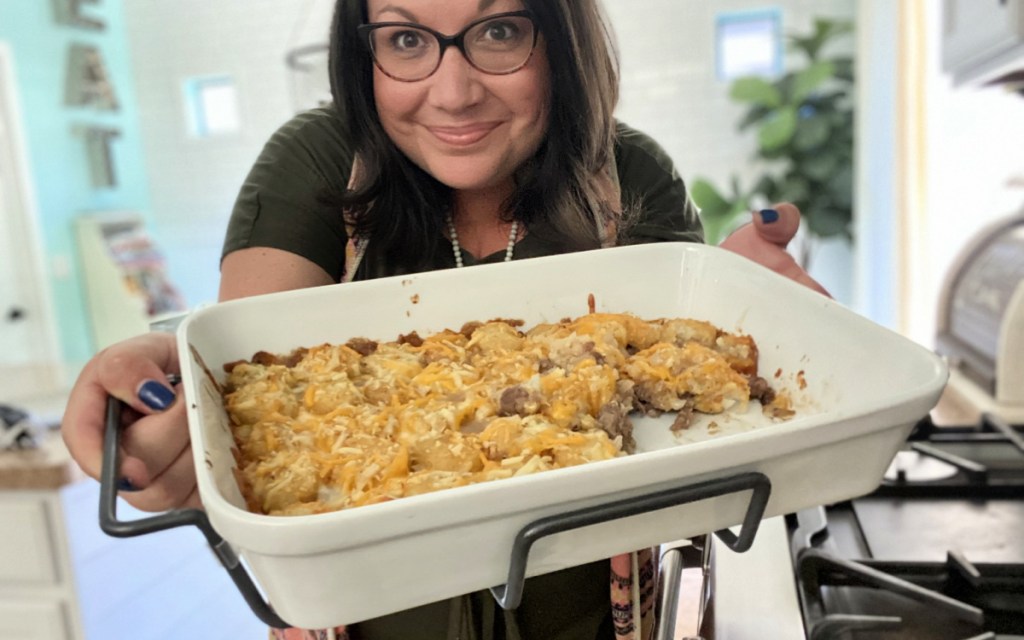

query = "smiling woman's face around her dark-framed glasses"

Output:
[[367, 0, 551, 190]]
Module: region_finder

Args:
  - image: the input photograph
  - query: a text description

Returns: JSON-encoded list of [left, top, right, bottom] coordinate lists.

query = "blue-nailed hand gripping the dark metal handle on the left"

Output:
[[60, 333, 200, 511]]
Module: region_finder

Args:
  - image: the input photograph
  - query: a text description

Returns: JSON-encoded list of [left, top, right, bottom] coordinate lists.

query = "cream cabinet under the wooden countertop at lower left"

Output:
[[0, 490, 83, 640]]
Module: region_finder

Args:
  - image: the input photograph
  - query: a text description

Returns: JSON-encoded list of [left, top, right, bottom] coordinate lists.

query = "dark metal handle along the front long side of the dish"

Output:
[[490, 471, 771, 609]]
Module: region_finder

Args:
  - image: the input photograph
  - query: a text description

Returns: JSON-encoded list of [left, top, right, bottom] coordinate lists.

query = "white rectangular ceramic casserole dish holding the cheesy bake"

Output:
[[178, 243, 947, 628]]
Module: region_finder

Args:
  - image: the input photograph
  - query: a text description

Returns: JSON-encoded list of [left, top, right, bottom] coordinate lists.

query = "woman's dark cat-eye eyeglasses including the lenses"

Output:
[[357, 11, 537, 82]]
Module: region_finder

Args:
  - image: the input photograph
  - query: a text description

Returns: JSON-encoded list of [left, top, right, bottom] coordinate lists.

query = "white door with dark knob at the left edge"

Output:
[[0, 42, 57, 402]]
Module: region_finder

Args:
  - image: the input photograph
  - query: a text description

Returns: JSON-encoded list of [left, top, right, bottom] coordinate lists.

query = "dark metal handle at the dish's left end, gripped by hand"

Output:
[[99, 397, 291, 629]]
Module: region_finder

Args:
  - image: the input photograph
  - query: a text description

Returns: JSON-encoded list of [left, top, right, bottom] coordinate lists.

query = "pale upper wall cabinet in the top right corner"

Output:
[[942, 0, 1024, 84]]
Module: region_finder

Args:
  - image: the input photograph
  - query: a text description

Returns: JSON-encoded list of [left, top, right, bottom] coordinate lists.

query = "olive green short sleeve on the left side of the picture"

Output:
[[221, 108, 352, 281]]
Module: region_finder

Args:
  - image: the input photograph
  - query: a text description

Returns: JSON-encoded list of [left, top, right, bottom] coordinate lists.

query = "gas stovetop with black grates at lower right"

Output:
[[790, 417, 1024, 640]]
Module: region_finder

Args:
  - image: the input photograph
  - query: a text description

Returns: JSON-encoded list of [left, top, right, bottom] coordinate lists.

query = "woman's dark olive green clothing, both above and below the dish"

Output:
[[223, 106, 702, 640]]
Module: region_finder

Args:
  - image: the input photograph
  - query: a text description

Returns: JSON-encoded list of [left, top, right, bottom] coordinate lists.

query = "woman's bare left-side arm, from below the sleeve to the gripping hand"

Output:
[[61, 247, 334, 511]]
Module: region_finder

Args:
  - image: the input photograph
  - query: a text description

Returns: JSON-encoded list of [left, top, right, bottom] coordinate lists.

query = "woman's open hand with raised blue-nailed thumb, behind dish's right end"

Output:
[[721, 203, 830, 297]]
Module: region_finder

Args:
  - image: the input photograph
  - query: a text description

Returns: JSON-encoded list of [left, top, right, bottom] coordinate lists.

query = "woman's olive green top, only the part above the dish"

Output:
[[223, 106, 703, 282]]
